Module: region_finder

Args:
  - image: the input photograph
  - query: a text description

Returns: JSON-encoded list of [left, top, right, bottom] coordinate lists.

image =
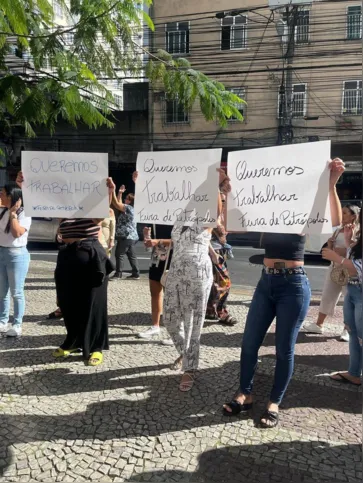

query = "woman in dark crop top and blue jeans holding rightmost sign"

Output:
[[223, 159, 344, 428]]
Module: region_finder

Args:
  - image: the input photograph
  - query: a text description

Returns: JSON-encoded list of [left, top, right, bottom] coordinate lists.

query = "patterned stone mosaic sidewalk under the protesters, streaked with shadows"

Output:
[[0, 262, 362, 483]]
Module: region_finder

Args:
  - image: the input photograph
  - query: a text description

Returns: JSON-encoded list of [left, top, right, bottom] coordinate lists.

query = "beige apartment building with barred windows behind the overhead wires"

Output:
[[150, 0, 362, 193]]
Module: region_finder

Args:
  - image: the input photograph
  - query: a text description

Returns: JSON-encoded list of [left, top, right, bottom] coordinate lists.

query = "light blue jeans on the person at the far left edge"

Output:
[[0, 247, 30, 326]]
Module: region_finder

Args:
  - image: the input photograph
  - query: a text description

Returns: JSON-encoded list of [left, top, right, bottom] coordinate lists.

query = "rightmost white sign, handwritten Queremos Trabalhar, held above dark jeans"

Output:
[[227, 141, 332, 234]]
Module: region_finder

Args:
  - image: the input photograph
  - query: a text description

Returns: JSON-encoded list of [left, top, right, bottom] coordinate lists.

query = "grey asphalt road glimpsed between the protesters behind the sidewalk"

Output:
[[29, 243, 327, 293]]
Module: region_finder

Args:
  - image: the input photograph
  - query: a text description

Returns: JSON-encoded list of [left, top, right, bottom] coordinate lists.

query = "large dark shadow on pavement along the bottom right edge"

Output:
[[127, 441, 361, 483]]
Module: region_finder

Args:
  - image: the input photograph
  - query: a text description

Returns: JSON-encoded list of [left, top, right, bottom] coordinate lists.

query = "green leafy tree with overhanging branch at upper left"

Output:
[[0, 0, 243, 140]]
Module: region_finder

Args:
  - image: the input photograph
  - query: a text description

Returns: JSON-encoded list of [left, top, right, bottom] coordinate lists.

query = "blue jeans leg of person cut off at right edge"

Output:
[[343, 285, 363, 377]]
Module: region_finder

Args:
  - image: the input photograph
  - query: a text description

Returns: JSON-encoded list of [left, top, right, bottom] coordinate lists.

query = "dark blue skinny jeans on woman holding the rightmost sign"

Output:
[[240, 272, 311, 404]]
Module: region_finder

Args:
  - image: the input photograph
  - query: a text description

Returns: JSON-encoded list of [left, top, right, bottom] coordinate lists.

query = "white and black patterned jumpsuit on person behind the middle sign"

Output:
[[164, 224, 213, 371]]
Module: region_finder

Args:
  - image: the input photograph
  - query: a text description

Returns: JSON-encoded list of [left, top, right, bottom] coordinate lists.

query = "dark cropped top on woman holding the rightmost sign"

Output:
[[262, 233, 306, 262]]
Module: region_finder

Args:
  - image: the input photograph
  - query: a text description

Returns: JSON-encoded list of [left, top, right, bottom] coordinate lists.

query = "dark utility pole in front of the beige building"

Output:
[[277, 5, 299, 144]]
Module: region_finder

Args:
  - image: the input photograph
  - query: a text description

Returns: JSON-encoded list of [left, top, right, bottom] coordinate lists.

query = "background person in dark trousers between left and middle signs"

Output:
[[111, 184, 140, 280]]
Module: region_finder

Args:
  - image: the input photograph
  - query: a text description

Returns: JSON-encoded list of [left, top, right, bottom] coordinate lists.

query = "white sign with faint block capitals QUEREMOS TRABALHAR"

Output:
[[22, 151, 109, 218]]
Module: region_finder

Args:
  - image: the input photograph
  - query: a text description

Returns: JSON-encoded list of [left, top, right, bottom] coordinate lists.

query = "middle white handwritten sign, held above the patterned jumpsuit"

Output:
[[135, 149, 222, 226]]
